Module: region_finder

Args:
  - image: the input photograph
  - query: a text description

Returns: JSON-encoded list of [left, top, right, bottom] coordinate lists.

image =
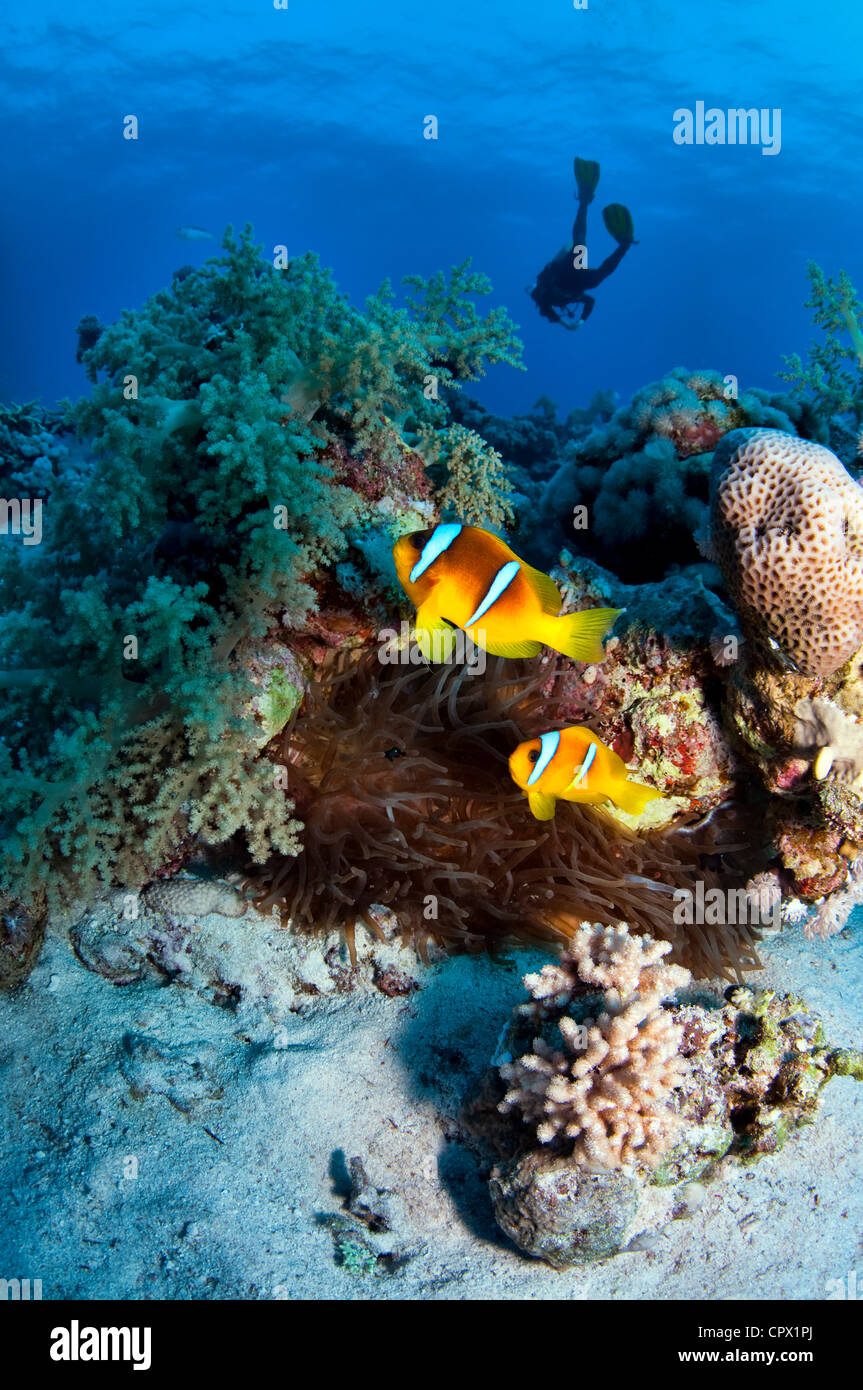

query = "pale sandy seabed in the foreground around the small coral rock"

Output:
[[0, 895, 863, 1300]]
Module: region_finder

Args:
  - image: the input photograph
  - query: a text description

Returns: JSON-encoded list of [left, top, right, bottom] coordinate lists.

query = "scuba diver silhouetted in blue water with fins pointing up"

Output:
[[528, 158, 638, 329]]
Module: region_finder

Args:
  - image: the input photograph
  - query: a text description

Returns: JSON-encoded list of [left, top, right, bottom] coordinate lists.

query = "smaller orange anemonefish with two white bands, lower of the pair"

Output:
[[510, 724, 661, 820]]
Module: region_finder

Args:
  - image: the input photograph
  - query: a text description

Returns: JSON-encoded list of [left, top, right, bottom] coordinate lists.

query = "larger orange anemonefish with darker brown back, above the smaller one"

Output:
[[392, 521, 623, 662]]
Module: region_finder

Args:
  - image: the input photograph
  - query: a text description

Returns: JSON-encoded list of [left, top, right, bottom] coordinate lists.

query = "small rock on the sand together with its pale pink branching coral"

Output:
[[478, 923, 863, 1269]]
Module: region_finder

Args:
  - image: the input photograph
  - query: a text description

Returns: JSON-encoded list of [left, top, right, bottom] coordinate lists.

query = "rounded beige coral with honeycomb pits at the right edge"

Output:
[[710, 430, 863, 676]]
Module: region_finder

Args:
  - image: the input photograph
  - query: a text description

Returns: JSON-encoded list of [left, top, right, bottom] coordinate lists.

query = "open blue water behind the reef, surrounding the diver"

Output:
[[0, 0, 863, 413]]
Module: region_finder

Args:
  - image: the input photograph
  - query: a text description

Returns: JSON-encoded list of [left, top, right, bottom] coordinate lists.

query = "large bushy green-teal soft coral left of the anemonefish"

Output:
[[0, 231, 517, 899]]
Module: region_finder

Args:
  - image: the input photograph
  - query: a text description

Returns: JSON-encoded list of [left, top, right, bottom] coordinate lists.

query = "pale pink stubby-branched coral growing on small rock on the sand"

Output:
[[500, 923, 689, 1168]]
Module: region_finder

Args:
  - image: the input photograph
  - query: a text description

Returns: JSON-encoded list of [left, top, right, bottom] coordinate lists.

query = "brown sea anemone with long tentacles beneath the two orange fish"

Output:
[[252, 653, 757, 977]]
